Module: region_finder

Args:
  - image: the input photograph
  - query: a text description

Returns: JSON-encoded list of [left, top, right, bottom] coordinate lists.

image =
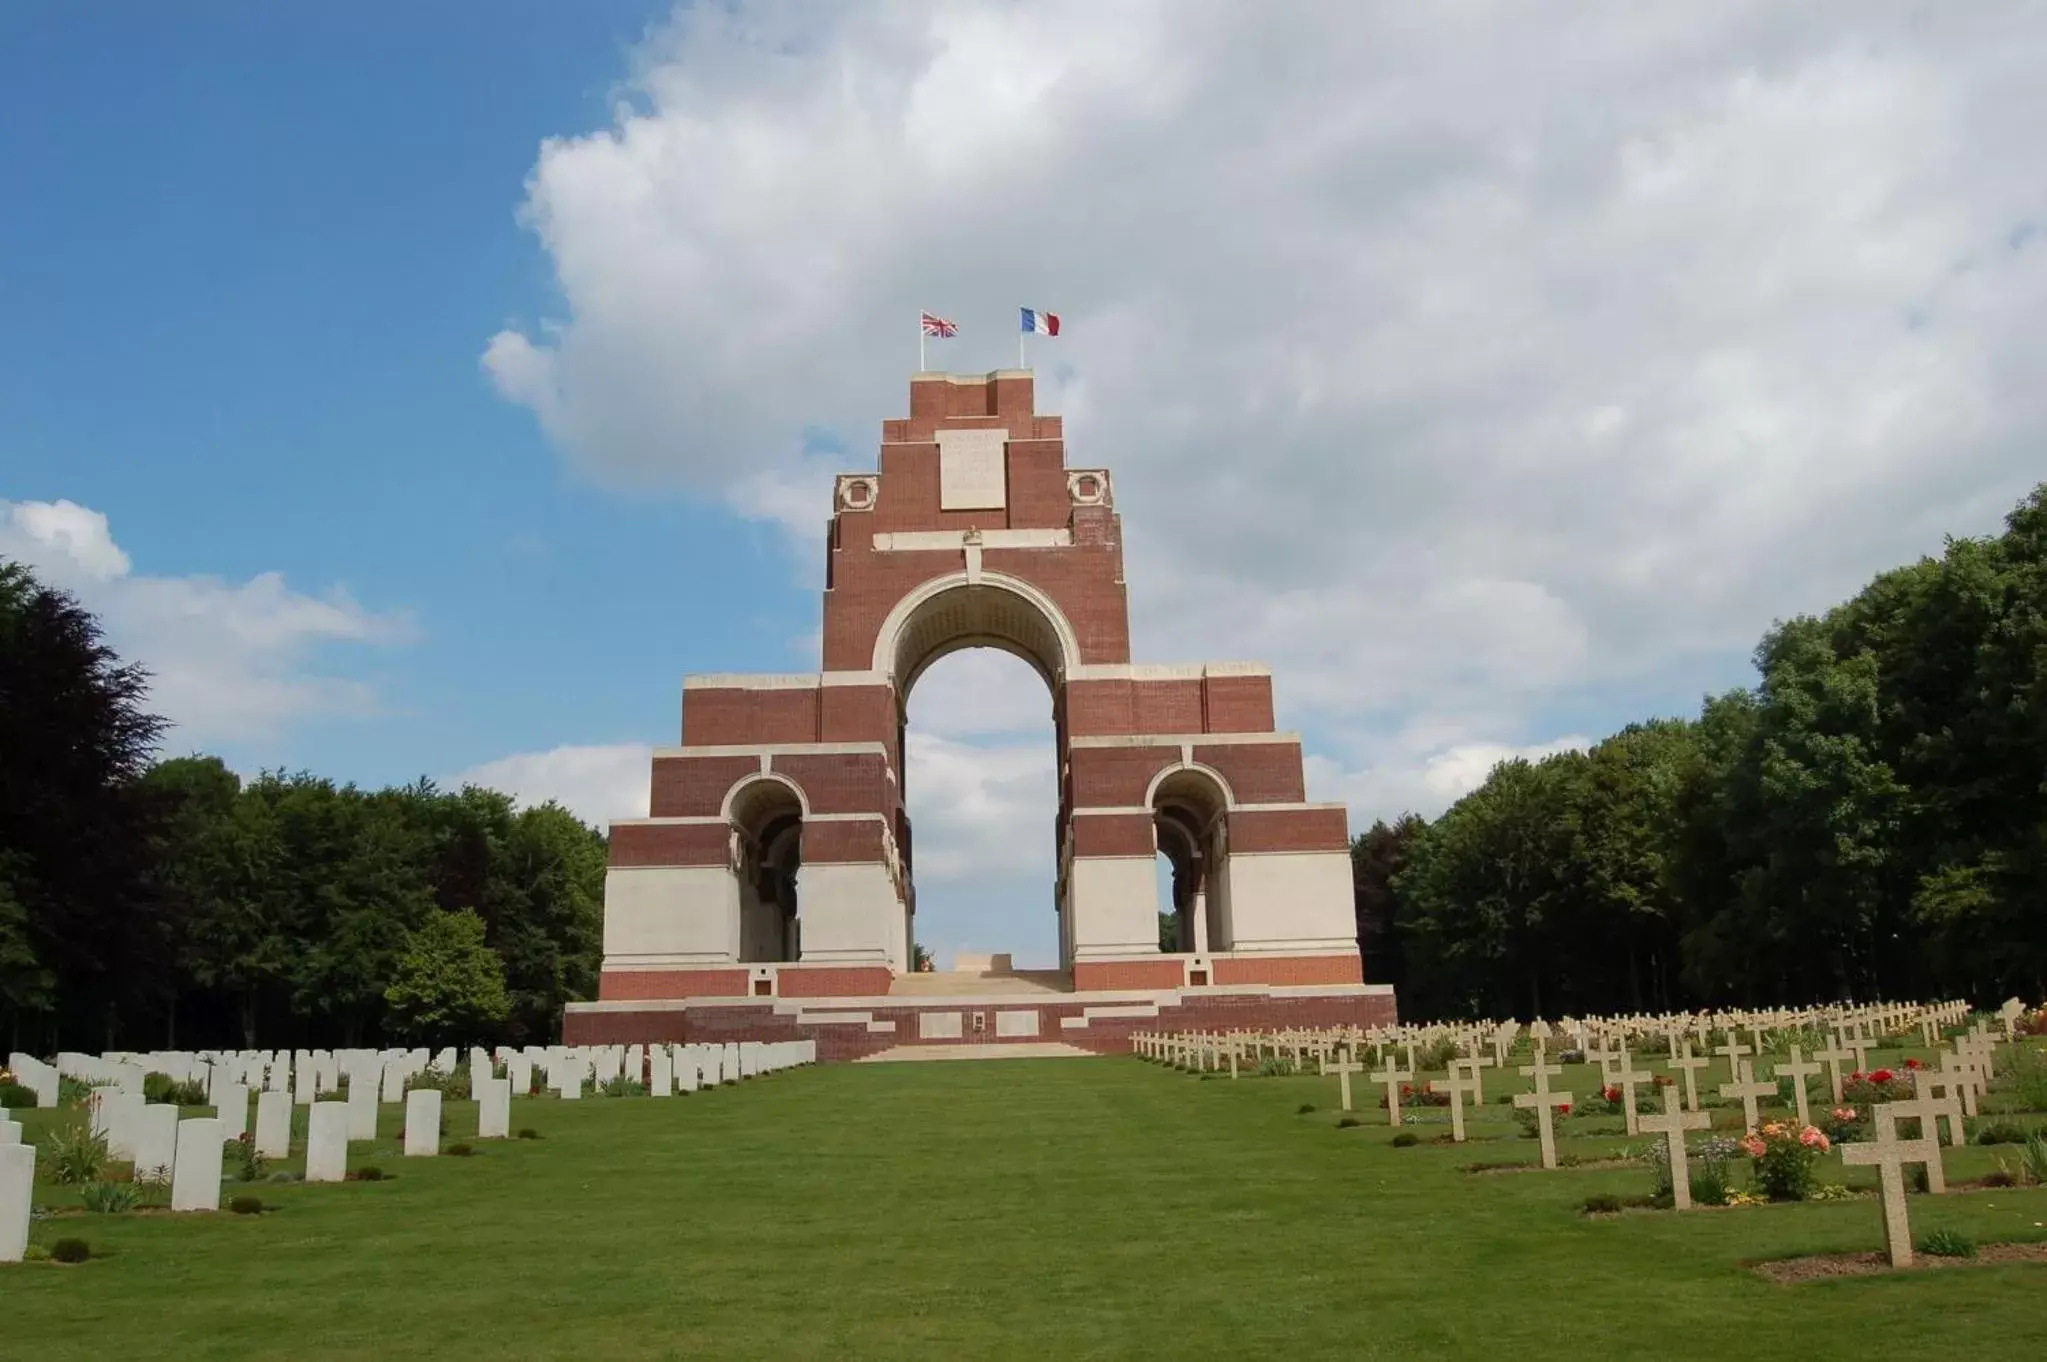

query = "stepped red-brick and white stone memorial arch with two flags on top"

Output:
[[565, 371, 1394, 1057]]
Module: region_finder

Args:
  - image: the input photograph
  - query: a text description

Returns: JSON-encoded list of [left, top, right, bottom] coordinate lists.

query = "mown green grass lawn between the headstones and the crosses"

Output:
[[0, 1044, 2047, 1362]]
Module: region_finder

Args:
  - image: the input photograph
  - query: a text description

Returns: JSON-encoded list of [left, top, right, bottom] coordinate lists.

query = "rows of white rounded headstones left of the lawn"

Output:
[[0, 1040, 817, 1262]]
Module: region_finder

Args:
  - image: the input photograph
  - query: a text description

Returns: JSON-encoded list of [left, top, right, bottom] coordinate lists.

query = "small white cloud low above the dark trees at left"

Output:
[[0, 500, 411, 743]]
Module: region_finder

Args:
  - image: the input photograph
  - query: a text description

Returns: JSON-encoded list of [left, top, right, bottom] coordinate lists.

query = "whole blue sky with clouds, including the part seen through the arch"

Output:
[[0, 0, 2047, 959]]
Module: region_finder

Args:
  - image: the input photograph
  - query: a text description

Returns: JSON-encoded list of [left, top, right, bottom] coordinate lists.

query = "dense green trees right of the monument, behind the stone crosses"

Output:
[[1351, 483, 2047, 1018]]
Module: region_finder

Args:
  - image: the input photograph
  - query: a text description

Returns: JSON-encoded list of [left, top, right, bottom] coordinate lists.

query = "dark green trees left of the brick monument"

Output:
[[0, 561, 606, 1051]]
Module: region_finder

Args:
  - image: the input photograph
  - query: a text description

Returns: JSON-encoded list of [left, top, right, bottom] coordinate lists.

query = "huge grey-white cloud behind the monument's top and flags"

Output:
[[483, 0, 2047, 813]]
